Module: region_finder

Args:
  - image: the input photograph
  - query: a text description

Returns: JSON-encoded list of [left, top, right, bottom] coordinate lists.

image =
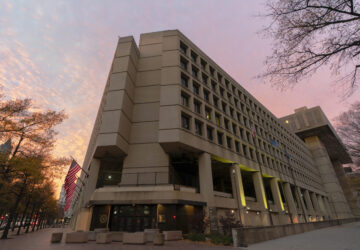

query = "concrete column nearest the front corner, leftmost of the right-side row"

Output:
[[199, 153, 218, 232]]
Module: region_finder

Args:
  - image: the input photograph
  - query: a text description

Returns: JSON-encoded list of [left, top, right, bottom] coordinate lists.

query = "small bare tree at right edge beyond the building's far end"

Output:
[[336, 101, 360, 165]]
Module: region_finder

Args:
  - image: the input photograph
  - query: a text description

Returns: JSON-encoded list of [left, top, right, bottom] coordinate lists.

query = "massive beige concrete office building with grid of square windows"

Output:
[[74, 30, 353, 232]]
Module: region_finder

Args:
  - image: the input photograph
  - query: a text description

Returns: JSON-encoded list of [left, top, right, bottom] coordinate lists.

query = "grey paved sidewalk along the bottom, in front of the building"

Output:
[[0, 222, 360, 250]]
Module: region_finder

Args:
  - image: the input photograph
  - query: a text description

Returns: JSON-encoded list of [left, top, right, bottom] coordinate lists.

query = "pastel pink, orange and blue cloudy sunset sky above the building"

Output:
[[0, 0, 360, 194]]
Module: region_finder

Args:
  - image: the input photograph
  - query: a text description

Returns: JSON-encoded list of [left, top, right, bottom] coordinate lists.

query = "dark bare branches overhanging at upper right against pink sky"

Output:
[[262, 0, 360, 94]]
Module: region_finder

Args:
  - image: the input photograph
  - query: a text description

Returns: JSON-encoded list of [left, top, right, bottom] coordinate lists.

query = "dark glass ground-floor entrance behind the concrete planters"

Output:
[[109, 205, 156, 232]]
